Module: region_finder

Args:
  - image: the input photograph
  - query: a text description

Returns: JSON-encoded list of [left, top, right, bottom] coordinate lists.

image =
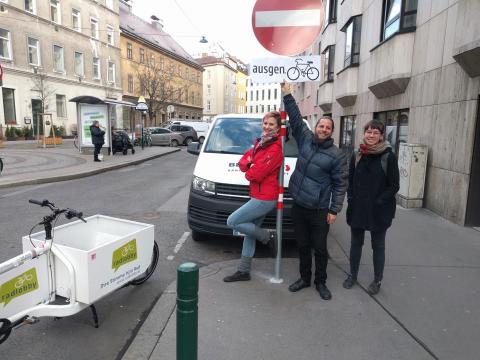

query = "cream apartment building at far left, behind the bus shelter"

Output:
[[0, 0, 122, 133]]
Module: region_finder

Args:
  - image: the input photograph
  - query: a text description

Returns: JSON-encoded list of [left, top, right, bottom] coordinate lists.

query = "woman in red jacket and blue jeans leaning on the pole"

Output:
[[223, 111, 283, 282]]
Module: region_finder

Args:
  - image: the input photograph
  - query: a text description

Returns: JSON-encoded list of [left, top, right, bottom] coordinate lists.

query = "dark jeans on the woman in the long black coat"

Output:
[[350, 229, 387, 282]]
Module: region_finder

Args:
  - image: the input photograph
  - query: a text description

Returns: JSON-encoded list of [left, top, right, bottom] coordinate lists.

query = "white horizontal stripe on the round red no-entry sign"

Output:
[[255, 9, 321, 27]]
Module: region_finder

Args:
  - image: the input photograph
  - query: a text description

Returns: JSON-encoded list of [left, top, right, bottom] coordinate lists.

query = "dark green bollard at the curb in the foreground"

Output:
[[177, 263, 198, 360]]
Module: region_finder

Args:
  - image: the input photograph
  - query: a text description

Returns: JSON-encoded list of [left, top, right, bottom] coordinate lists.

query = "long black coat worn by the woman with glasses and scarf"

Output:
[[347, 148, 400, 231]]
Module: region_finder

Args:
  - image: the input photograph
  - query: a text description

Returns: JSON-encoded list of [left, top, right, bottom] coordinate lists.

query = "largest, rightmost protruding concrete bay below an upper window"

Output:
[[368, 33, 415, 99]]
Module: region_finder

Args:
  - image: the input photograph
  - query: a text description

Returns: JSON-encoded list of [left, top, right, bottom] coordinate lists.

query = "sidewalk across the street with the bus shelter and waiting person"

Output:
[[0, 140, 180, 188]]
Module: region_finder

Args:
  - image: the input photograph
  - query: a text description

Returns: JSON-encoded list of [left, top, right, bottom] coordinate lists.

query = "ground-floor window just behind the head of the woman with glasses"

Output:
[[373, 109, 409, 154]]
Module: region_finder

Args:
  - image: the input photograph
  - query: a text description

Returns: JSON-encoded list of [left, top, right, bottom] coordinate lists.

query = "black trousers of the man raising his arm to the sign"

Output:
[[292, 203, 330, 284]]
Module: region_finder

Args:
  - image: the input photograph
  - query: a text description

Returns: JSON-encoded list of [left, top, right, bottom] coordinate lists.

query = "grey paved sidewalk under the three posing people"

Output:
[[123, 208, 480, 360]]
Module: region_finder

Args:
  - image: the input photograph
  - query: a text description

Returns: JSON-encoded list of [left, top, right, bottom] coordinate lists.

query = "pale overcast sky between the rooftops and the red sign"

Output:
[[133, 0, 275, 63]]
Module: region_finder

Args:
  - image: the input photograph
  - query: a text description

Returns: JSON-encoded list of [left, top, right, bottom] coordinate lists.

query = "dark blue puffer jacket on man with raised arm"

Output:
[[283, 94, 347, 214]]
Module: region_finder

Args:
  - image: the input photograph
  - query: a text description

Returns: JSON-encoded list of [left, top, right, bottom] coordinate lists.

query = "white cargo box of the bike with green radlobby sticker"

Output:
[[22, 215, 154, 304]]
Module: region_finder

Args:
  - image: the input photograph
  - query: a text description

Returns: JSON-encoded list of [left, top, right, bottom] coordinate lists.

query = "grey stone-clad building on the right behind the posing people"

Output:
[[295, 0, 480, 226]]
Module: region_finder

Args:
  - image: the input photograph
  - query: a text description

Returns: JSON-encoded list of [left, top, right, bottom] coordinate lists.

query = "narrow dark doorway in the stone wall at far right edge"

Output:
[[465, 95, 480, 226]]
